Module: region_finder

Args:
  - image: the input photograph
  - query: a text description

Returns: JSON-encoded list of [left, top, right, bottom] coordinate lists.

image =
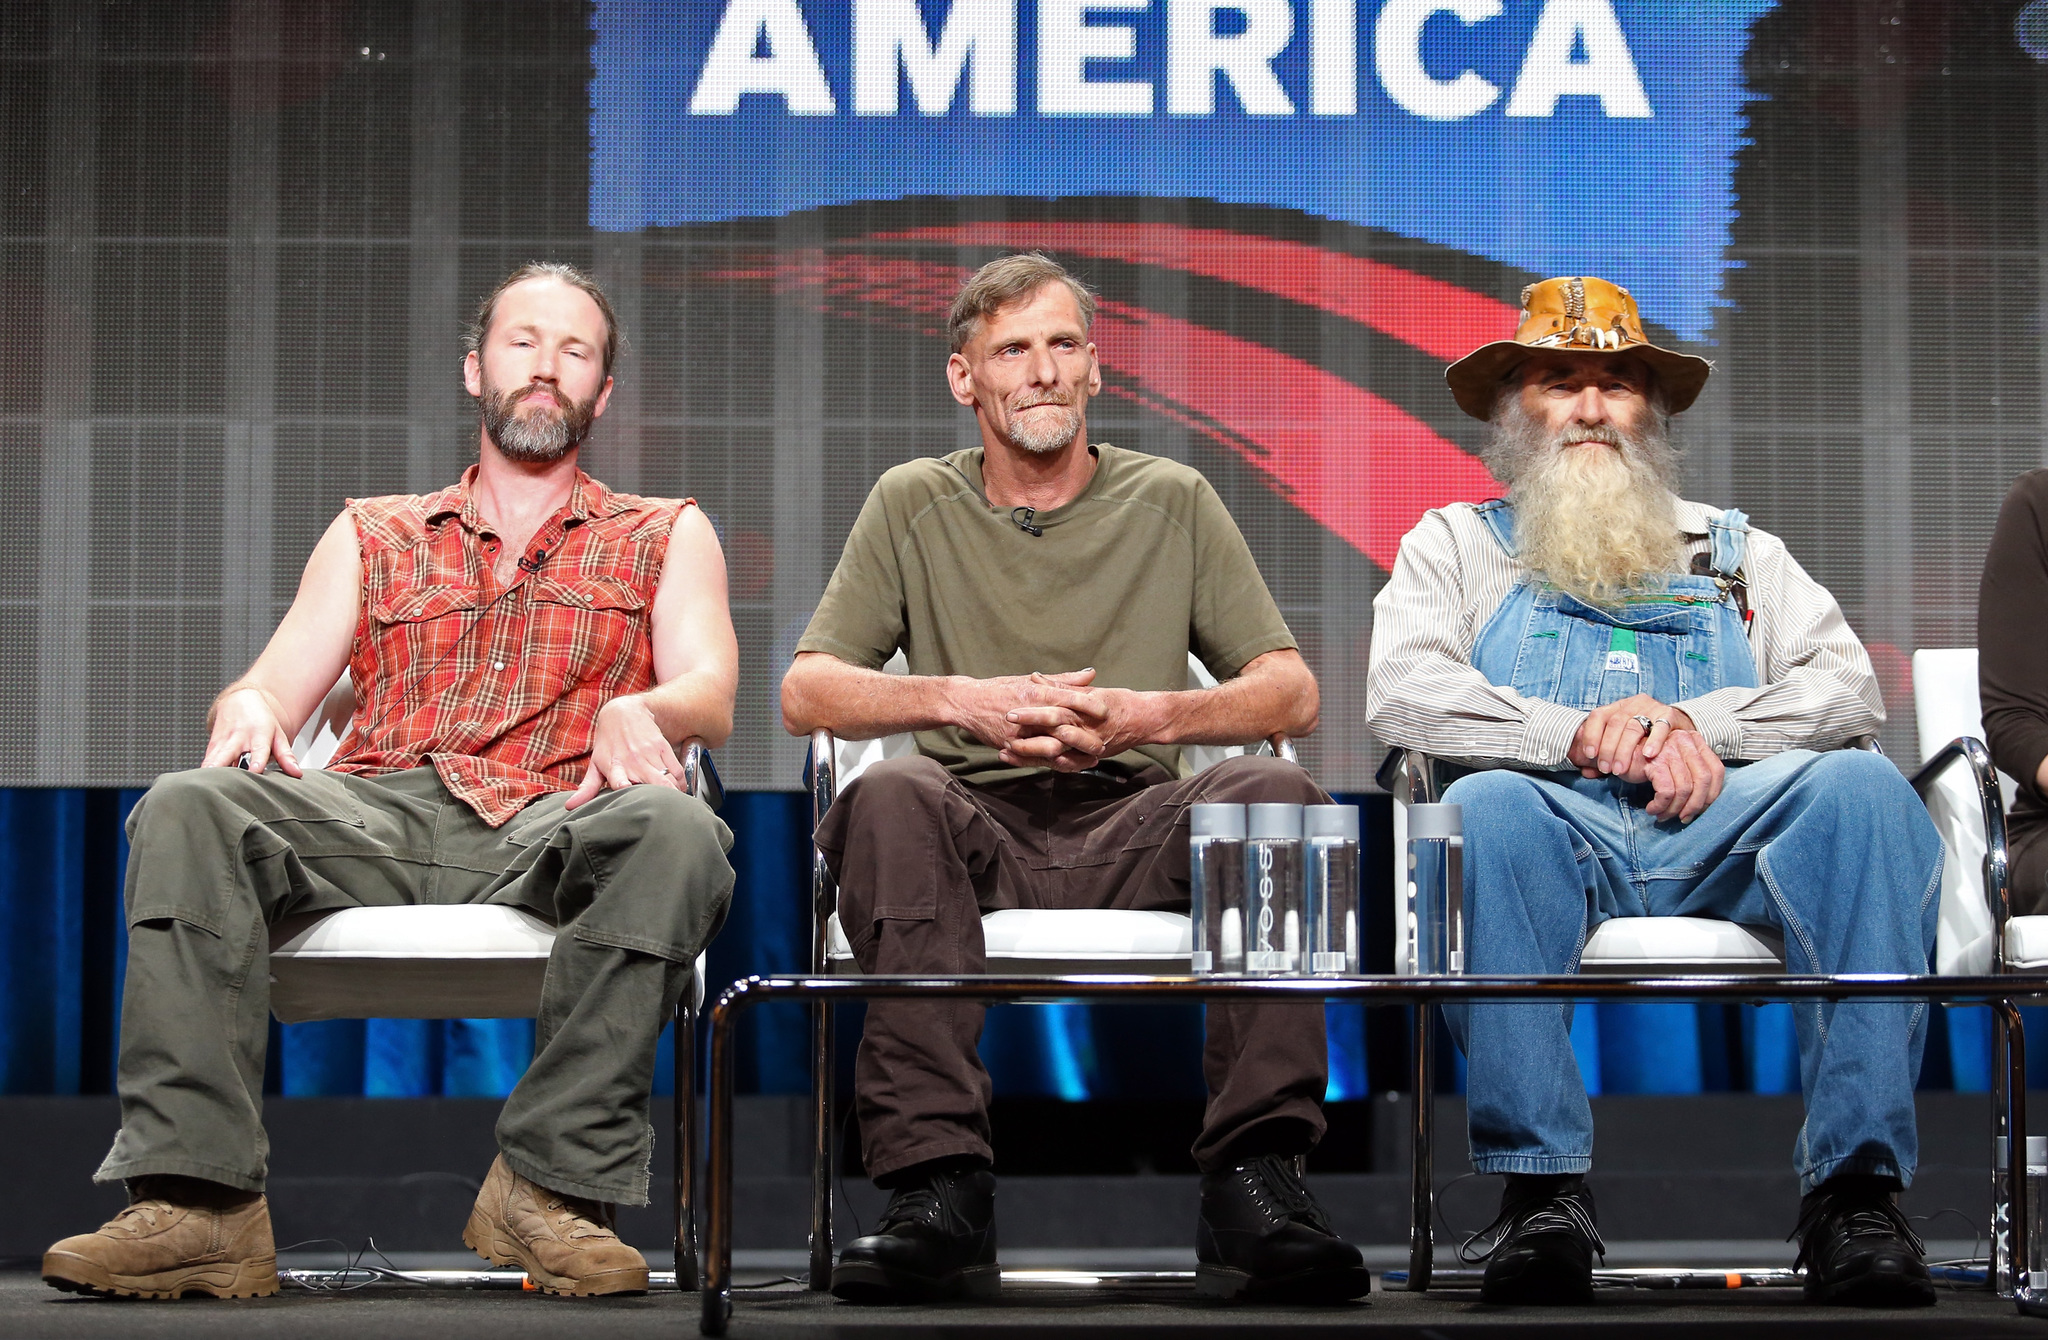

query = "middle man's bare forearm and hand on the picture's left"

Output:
[[782, 652, 1096, 748]]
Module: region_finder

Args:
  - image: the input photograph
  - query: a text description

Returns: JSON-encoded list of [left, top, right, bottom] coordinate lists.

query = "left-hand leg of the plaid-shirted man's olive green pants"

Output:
[[94, 768, 432, 1190]]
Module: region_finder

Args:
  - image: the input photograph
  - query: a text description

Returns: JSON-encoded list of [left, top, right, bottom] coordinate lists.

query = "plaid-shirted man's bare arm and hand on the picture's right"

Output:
[[569, 506, 739, 809]]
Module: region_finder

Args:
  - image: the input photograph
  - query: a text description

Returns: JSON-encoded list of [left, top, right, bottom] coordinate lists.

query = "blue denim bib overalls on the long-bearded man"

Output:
[[1444, 502, 1942, 1190]]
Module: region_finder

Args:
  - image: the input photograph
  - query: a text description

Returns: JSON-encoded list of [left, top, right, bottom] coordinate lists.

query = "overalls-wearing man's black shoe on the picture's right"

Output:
[[1792, 1176, 1933, 1307]]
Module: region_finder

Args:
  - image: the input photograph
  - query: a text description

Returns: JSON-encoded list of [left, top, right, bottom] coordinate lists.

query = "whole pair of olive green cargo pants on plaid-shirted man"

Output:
[[96, 768, 733, 1205]]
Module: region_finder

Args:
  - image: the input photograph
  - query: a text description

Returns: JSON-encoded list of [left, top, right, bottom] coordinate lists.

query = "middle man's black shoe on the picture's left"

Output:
[[831, 1168, 1004, 1303]]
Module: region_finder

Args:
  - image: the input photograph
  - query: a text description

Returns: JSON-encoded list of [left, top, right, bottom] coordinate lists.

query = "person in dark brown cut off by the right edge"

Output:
[[1976, 469, 2048, 916]]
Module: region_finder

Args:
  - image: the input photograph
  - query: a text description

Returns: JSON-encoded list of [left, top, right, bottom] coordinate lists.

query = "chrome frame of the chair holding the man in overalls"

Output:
[[1378, 736, 2042, 1297]]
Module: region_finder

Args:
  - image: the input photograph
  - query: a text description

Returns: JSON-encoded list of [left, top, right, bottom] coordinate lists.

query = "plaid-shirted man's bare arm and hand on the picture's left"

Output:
[[201, 512, 362, 777]]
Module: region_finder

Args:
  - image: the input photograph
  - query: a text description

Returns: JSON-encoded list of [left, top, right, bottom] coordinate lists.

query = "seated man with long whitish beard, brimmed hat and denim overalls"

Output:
[[1366, 277, 1942, 1305]]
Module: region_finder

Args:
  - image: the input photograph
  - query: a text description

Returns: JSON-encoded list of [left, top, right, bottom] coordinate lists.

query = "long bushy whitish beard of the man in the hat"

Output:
[[1485, 395, 1683, 604]]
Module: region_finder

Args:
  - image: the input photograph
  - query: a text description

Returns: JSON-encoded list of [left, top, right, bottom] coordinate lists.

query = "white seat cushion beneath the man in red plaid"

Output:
[[270, 904, 555, 1024]]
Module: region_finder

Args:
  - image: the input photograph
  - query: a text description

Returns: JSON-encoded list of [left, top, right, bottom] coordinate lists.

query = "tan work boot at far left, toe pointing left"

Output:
[[43, 1176, 276, 1299]]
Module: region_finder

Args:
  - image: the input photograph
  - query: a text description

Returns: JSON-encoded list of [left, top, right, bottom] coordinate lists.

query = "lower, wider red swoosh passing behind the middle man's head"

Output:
[[713, 250, 1501, 570]]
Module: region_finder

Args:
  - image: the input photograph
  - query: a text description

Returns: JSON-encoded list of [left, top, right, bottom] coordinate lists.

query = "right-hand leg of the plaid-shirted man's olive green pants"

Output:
[[487, 787, 733, 1205]]
